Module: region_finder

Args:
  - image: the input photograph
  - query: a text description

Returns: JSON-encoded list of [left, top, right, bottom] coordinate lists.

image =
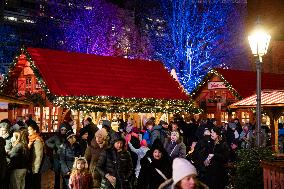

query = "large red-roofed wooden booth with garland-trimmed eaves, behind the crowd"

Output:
[[1, 48, 201, 132]]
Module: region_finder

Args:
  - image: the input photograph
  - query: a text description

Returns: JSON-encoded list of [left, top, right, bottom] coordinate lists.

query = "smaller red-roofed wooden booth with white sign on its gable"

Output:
[[191, 68, 284, 124]]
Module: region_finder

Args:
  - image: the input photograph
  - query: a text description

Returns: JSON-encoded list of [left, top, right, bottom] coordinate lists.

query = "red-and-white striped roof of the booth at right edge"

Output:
[[229, 90, 284, 108]]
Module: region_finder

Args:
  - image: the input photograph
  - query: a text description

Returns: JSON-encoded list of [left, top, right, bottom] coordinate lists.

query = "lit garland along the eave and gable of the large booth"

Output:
[[1, 48, 202, 114]]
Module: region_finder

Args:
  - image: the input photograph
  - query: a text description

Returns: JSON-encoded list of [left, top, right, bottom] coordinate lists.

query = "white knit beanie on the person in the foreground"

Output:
[[173, 158, 197, 186]]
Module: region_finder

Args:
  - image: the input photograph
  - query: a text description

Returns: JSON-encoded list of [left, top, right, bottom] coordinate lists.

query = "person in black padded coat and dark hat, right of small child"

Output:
[[96, 137, 133, 189]]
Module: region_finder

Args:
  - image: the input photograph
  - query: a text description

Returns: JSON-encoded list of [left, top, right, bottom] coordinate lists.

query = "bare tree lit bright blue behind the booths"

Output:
[[138, 0, 246, 91]]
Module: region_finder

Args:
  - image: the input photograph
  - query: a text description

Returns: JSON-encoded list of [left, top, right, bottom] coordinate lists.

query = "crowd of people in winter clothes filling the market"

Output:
[[0, 116, 267, 189]]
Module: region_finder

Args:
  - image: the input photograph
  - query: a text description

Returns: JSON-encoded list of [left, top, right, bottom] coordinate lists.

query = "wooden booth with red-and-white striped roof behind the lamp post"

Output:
[[229, 90, 284, 153]]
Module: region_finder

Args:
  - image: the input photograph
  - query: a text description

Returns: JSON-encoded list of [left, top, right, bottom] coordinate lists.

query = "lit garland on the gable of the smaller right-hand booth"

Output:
[[191, 69, 243, 100]]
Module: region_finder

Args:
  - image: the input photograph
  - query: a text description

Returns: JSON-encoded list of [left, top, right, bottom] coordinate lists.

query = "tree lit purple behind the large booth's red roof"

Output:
[[53, 0, 151, 58]]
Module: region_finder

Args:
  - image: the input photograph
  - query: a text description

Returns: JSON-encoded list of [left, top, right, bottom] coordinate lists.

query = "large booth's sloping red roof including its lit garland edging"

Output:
[[1, 48, 200, 112]]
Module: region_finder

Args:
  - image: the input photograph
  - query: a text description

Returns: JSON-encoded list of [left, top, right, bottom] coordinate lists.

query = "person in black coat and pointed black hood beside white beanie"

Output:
[[137, 139, 172, 189]]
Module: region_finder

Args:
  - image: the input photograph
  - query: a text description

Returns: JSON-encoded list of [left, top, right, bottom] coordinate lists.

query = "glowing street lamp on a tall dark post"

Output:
[[248, 23, 271, 146]]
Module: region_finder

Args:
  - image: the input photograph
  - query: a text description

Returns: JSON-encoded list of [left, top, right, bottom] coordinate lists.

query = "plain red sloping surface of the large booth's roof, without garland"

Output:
[[27, 48, 189, 100]]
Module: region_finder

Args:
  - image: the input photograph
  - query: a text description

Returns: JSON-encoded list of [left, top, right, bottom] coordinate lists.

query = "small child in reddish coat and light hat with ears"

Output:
[[69, 157, 92, 189]]
